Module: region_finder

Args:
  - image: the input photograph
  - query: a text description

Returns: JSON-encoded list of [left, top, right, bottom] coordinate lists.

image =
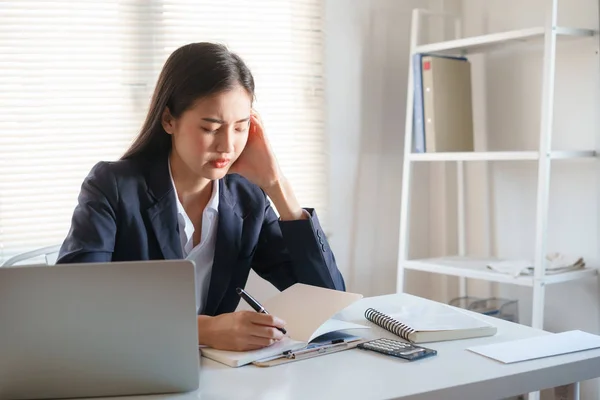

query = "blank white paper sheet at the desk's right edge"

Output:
[[468, 330, 600, 364]]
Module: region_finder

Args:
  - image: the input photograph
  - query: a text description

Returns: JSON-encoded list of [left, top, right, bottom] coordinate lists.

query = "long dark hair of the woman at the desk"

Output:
[[121, 43, 254, 159]]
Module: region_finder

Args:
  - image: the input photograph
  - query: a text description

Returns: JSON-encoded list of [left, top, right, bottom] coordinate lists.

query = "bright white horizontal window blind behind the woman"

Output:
[[0, 0, 327, 264]]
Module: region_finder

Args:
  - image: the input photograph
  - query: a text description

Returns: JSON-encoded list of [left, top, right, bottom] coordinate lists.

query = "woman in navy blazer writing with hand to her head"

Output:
[[57, 43, 345, 350]]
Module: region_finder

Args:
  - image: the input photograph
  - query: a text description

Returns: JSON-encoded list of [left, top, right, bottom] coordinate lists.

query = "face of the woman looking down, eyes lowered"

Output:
[[163, 86, 252, 180]]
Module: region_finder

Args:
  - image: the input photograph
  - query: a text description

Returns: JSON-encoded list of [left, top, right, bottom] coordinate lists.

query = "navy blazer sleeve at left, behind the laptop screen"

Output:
[[56, 162, 118, 264]]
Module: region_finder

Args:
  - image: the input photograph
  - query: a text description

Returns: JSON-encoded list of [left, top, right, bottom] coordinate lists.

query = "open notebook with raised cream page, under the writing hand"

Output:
[[201, 283, 368, 367]]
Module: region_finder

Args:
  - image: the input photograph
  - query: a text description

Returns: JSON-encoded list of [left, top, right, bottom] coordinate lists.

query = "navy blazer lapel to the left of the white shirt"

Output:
[[146, 154, 183, 260]]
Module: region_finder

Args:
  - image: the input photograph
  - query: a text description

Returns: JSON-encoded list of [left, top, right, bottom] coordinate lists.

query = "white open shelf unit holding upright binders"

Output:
[[396, 0, 598, 336]]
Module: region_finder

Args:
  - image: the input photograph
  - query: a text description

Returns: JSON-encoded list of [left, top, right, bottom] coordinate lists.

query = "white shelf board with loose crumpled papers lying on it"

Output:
[[402, 257, 598, 287]]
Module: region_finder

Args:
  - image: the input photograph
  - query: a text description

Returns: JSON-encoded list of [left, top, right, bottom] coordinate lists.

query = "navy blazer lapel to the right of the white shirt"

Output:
[[203, 179, 243, 315]]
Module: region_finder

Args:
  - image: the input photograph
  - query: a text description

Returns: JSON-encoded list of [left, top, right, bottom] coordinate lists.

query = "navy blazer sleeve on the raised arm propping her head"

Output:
[[252, 198, 346, 291]]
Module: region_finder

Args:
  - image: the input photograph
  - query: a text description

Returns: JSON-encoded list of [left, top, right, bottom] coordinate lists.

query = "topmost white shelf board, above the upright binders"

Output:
[[415, 26, 596, 54]]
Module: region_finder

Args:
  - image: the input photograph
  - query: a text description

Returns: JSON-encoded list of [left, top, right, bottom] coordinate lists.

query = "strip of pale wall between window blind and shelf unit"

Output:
[[325, 0, 438, 296]]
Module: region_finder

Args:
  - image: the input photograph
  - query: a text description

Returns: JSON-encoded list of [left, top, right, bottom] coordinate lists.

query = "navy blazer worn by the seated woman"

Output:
[[57, 155, 345, 315]]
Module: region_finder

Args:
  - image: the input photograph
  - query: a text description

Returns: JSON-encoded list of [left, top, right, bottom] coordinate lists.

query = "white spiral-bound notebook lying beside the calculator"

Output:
[[365, 303, 497, 343]]
